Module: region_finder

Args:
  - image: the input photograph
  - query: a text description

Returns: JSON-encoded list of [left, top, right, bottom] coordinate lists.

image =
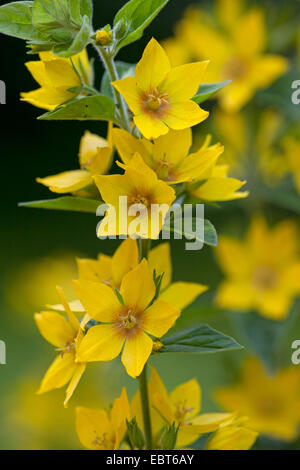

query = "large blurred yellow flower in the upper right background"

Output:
[[165, 0, 288, 112]]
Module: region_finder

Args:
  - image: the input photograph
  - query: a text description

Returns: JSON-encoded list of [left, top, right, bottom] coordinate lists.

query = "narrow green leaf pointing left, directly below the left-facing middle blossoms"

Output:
[[18, 196, 102, 214]]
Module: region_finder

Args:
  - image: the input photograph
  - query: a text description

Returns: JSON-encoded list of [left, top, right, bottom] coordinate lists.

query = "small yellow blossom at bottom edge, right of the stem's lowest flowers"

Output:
[[205, 415, 258, 450]]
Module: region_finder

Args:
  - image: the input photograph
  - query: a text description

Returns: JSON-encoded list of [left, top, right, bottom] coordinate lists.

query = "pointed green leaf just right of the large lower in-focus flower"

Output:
[[158, 325, 243, 354]]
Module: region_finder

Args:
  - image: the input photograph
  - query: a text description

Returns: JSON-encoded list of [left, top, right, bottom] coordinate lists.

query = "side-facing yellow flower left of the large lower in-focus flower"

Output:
[[35, 287, 86, 407]]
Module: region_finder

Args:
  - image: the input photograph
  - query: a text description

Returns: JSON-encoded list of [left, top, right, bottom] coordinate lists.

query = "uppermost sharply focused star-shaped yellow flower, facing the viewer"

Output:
[[112, 39, 208, 139]]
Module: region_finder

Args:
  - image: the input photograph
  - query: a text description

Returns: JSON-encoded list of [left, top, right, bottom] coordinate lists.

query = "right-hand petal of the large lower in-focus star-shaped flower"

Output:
[[142, 299, 180, 338]]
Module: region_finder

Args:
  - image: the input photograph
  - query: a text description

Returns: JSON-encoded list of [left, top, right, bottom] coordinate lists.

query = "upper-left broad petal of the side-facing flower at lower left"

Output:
[[34, 312, 74, 348]]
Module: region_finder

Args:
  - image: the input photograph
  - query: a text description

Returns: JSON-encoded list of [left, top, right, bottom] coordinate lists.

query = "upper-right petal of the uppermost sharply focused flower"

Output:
[[160, 61, 209, 103]]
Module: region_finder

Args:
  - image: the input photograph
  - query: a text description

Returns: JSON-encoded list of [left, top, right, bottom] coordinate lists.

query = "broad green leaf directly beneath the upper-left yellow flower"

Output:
[[38, 95, 117, 122]]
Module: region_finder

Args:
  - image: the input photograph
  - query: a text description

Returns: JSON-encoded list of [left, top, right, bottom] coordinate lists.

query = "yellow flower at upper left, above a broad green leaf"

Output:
[[21, 49, 92, 111]]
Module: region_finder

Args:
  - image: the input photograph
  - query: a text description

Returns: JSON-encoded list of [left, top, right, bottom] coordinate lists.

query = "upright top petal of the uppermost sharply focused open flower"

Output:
[[135, 38, 171, 92]]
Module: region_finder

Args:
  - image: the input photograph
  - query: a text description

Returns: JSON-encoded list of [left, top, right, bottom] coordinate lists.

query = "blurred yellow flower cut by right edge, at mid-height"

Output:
[[216, 218, 300, 320]]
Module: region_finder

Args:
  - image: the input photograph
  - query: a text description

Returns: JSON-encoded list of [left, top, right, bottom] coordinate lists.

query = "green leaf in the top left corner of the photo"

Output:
[[0, 2, 43, 41]]
